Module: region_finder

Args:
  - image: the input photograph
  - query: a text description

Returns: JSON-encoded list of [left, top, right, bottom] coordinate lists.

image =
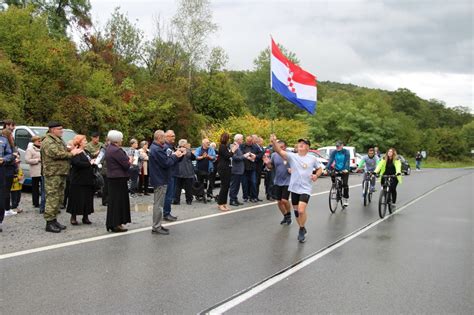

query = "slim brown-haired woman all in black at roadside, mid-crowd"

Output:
[[217, 132, 237, 211]]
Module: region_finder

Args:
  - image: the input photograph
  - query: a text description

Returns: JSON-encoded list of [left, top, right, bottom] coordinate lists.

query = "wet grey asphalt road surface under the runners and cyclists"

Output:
[[0, 169, 474, 314]]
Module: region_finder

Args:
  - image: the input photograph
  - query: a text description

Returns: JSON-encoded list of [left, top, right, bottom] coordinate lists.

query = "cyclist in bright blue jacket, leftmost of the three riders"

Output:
[[326, 141, 351, 207]]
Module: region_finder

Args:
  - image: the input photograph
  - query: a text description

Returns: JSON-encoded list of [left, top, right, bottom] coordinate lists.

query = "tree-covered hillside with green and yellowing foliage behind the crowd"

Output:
[[0, 7, 474, 160]]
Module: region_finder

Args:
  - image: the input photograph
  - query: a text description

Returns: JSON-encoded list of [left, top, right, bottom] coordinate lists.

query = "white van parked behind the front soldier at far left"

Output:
[[13, 126, 77, 186]]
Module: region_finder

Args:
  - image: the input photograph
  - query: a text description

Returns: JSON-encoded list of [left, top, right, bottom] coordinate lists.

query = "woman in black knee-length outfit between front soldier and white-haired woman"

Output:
[[66, 135, 94, 225]]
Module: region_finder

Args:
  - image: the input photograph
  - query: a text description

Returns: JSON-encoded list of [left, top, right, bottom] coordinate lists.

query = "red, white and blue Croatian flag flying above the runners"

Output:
[[270, 38, 317, 115]]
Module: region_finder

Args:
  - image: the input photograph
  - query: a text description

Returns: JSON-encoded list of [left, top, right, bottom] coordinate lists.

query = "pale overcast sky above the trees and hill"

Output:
[[91, 0, 474, 111]]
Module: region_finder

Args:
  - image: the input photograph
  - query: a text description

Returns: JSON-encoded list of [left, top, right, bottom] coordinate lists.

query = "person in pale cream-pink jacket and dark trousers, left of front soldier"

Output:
[[25, 136, 41, 208]]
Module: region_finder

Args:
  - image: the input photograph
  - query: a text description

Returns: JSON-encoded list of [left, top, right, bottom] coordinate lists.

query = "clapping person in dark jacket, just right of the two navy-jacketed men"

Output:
[[173, 139, 196, 205]]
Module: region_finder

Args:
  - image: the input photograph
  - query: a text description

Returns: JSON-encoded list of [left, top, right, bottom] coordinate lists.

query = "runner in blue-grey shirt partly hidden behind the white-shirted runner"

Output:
[[263, 140, 291, 225]]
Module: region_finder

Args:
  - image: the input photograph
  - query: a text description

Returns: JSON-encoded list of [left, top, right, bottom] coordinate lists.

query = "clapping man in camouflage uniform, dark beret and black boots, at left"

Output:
[[41, 122, 82, 233]]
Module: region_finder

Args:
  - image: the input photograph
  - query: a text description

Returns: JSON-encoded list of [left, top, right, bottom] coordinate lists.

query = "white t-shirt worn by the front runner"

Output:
[[286, 152, 321, 195]]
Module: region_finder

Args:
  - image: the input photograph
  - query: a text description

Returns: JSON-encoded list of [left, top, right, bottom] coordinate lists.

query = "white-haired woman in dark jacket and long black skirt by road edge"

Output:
[[105, 130, 133, 233]]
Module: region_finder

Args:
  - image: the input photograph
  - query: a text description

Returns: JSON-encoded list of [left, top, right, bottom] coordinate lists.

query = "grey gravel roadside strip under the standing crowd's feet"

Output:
[[0, 176, 338, 254]]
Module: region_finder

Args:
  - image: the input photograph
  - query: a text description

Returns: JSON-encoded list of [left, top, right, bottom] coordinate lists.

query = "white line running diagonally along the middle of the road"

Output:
[[204, 175, 465, 315]]
